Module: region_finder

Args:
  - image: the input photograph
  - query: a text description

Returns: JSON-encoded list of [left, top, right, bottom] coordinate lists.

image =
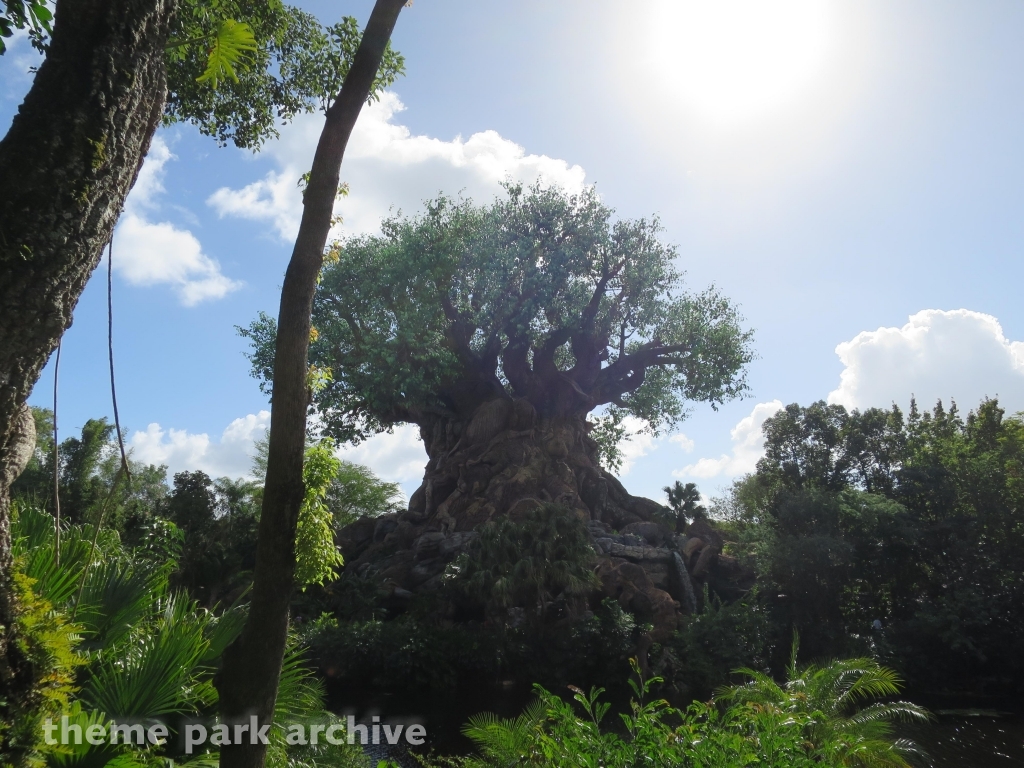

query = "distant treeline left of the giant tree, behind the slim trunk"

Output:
[[12, 409, 400, 608]]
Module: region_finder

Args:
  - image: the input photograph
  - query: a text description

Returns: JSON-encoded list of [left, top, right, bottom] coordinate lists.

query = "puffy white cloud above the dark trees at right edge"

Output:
[[828, 309, 1024, 412]]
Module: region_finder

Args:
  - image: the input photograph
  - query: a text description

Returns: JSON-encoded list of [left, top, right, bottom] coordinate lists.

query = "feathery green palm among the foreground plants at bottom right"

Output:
[[718, 636, 931, 768]]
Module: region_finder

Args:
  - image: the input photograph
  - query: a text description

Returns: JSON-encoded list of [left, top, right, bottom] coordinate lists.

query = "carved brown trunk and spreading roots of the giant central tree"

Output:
[[339, 393, 753, 656]]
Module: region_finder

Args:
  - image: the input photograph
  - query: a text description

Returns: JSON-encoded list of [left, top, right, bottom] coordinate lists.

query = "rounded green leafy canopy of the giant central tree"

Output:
[[240, 184, 752, 440]]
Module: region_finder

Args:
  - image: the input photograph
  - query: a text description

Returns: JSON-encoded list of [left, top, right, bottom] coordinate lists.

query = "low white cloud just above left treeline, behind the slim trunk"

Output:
[[128, 411, 427, 499]]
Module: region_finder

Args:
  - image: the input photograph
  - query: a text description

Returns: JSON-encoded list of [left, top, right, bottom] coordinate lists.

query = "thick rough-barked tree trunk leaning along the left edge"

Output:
[[0, 0, 176, 757]]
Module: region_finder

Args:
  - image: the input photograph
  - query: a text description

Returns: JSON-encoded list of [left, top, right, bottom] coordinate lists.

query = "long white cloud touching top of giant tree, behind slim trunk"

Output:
[[207, 92, 585, 240]]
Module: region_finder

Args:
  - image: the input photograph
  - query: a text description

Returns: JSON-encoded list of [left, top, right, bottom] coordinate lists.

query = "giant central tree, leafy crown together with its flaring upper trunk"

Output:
[[244, 185, 752, 530]]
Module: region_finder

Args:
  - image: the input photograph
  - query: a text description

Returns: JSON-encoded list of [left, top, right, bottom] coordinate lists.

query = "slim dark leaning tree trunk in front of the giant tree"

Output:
[[217, 0, 406, 768]]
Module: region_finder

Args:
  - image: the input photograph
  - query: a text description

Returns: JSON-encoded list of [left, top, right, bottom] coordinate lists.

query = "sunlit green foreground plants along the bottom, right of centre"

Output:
[[438, 658, 927, 768]]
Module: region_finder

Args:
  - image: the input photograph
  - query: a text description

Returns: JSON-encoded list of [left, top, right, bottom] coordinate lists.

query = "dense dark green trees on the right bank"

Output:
[[717, 400, 1024, 691]]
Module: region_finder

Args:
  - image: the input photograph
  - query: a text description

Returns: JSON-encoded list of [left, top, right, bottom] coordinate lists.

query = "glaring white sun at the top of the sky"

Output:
[[640, 0, 834, 124]]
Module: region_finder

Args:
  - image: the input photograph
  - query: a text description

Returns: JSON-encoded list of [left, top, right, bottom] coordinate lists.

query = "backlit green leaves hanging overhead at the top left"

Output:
[[0, 0, 406, 148]]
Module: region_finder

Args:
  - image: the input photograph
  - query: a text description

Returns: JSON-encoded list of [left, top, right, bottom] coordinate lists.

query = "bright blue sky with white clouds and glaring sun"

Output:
[[0, 0, 1024, 499]]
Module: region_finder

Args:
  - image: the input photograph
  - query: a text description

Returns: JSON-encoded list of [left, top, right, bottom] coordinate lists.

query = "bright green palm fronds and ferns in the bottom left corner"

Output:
[[6, 507, 365, 768]]
